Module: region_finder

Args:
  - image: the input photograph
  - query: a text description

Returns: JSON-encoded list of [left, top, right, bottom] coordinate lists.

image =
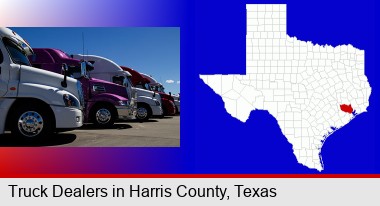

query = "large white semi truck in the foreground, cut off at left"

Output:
[[0, 28, 83, 141]]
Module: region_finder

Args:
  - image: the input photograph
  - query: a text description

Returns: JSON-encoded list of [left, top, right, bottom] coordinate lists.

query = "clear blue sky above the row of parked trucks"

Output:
[[11, 27, 180, 94]]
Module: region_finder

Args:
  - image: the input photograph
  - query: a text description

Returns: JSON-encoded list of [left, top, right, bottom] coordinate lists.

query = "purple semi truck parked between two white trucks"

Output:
[[29, 48, 137, 127]]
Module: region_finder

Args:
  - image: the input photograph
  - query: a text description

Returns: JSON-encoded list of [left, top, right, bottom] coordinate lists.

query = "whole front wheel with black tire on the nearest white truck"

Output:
[[11, 105, 54, 141]]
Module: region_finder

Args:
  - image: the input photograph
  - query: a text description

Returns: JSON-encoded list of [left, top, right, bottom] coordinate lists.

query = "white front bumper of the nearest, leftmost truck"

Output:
[[51, 106, 83, 129]]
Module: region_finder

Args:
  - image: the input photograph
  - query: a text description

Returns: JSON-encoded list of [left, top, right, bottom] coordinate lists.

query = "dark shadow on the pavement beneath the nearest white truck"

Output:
[[0, 134, 77, 147]]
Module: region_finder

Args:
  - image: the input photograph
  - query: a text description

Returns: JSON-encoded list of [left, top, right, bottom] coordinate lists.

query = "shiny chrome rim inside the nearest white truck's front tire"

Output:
[[18, 111, 44, 137]]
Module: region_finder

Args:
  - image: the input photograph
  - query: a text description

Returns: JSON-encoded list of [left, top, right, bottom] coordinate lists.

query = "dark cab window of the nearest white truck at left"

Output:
[[3, 38, 31, 66]]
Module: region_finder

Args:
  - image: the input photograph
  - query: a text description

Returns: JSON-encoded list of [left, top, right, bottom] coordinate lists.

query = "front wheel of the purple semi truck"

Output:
[[92, 105, 116, 127]]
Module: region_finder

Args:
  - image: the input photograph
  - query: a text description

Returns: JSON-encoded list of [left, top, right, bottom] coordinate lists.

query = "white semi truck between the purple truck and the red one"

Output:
[[71, 54, 163, 121]]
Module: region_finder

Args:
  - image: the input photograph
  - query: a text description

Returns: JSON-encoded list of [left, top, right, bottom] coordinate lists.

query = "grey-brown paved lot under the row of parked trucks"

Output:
[[0, 116, 180, 147]]
